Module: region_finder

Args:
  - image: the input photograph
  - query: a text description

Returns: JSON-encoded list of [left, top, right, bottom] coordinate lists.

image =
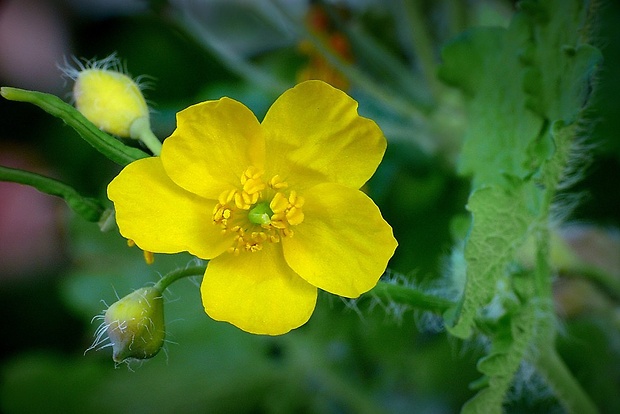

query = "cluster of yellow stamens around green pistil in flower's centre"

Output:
[[213, 167, 304, 254]]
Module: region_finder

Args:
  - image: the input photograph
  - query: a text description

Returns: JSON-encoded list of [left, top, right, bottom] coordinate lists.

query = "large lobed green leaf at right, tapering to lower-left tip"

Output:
[[439, 0, 598, 337]]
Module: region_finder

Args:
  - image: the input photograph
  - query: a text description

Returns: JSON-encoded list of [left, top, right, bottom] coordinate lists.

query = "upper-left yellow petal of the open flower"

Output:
[[161, 98, 265, 199]]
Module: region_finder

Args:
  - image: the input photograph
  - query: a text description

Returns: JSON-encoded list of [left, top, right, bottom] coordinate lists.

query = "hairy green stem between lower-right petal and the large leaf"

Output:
[[366, 282, 455, 313]]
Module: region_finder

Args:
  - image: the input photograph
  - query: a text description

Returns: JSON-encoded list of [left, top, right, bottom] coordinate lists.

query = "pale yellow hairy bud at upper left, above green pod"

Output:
[[73, 65, 149, 138]]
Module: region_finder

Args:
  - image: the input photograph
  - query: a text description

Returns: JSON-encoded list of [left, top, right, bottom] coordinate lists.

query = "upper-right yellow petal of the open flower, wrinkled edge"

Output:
[[262, 81, 386, 189]]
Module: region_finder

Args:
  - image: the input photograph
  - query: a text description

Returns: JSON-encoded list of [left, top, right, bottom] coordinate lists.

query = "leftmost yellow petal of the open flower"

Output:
[[108, 157, 231, 259]]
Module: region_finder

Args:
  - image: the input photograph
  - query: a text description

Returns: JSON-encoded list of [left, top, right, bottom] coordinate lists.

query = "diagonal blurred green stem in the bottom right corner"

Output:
[[536, 346, 599, 414]]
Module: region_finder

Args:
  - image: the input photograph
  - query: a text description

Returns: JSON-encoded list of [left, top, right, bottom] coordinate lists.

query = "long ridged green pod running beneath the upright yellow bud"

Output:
[[0, 87, 149, 166]]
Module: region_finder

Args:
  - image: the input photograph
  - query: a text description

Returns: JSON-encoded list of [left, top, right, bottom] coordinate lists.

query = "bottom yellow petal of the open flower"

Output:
[[200, 243, 317, 335]]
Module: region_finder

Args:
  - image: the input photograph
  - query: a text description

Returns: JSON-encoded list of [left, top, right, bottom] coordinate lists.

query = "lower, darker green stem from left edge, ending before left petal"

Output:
[[0, 166, 103, 221]]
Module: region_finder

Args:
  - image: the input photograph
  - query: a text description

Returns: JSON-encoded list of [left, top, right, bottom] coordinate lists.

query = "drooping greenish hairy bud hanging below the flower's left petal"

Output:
[[105, 287, 166, 362]]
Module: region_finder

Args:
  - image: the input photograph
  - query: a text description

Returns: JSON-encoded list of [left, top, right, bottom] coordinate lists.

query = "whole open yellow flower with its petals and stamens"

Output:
[[108, 81, 397, 335]]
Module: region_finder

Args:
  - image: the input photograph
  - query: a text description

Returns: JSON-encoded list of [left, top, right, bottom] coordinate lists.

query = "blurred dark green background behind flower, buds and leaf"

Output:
[[0, 0, 620, 413]]
